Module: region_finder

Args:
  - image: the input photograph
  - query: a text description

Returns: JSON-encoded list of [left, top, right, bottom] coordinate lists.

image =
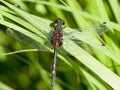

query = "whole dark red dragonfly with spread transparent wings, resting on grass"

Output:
[[7, 18, 108, 87]]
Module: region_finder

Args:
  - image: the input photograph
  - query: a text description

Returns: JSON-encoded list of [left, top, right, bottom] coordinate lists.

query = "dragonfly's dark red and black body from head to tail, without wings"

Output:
[[50, 18, 64, 87]]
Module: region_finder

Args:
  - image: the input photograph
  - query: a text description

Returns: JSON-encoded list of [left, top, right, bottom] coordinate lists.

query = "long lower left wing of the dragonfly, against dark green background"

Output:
[[6, 28, 49, 51]]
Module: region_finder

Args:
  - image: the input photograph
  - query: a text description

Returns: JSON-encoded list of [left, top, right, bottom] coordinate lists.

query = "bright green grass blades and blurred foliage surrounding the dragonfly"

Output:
[[0, 0, 120, 90]]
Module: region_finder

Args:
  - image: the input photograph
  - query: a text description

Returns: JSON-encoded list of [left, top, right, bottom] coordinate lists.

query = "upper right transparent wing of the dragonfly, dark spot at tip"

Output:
[[64, 22, 109, 38]]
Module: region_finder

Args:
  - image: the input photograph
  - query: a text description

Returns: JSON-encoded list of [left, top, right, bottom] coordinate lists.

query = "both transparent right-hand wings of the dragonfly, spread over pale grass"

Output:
[[63, 22, 109, 46]]
